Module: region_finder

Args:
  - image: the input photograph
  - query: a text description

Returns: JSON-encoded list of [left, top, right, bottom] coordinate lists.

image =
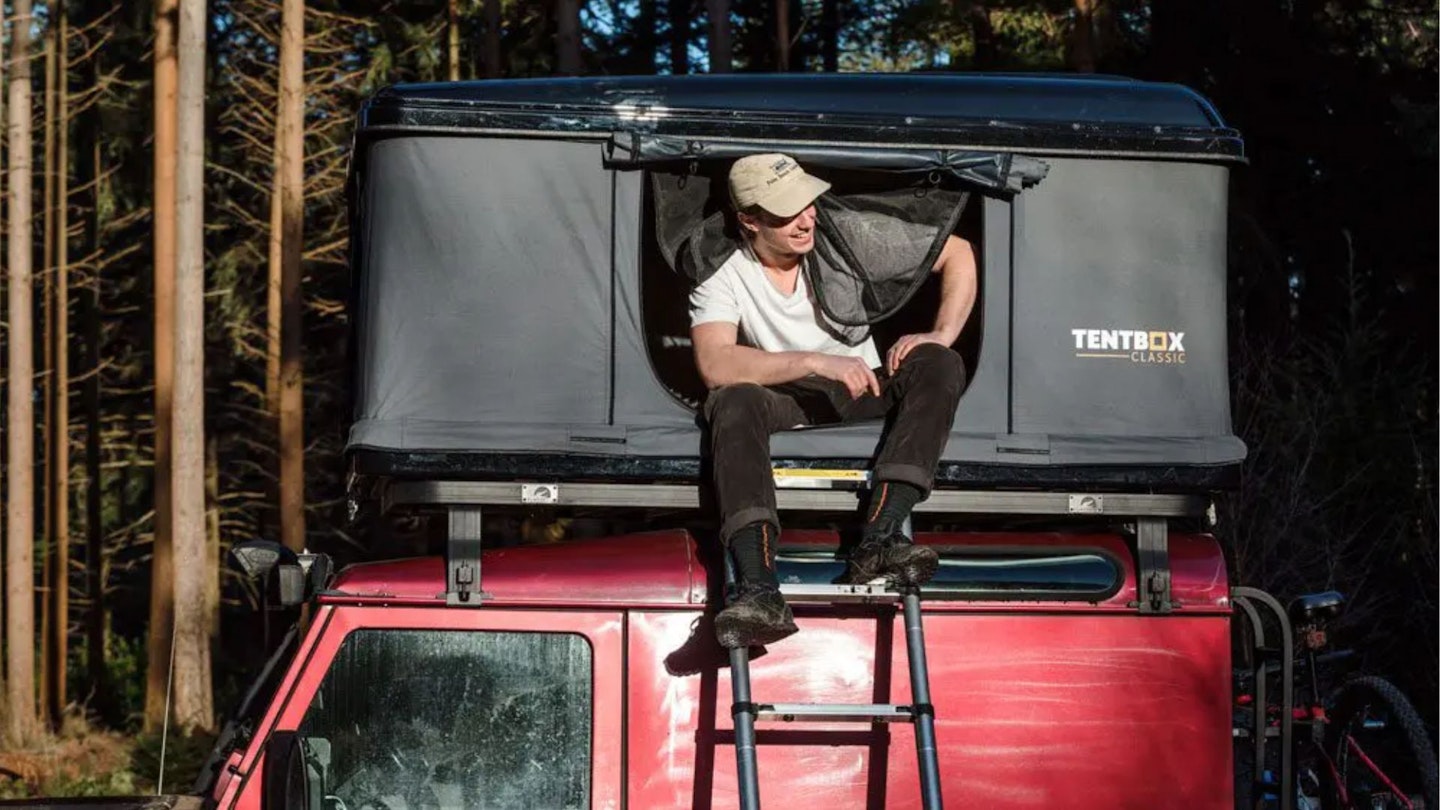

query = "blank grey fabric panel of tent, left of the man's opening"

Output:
[[353, 138, 611, 447]]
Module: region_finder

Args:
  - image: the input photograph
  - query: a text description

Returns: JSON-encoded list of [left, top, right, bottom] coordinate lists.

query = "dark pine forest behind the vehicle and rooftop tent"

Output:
[[0, 0, 1440, 794]]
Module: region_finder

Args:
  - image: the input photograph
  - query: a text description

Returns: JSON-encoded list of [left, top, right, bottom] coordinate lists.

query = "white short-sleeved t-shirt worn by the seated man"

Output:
[[690, 248, 880, 369]]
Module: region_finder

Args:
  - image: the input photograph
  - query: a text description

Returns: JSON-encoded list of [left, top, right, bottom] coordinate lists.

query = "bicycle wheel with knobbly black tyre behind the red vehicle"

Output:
[[1325, 676, 1440, 810]]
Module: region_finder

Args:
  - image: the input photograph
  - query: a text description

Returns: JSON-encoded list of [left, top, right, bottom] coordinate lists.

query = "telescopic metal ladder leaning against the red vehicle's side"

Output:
[[726, 576, 943, 810]]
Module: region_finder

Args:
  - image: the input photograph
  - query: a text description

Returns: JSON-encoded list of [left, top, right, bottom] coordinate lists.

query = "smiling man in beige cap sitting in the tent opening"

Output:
[[690, 154, 976, 647]]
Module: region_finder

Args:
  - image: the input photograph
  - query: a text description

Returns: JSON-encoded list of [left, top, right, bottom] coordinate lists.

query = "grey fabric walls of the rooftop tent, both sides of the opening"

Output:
[[347, 135, 1244, 467]]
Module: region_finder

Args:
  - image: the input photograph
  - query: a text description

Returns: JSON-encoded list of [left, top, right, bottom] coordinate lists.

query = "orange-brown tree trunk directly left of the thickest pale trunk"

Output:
[[144, 0, 179, 731]]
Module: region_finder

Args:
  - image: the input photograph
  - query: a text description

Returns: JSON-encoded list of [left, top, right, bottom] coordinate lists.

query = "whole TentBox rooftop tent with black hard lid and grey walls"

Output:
[[348, 75, 1244, 491]]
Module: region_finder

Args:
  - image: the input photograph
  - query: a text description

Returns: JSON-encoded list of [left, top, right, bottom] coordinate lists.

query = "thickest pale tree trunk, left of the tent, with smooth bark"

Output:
[[171, 0, 214, 731]]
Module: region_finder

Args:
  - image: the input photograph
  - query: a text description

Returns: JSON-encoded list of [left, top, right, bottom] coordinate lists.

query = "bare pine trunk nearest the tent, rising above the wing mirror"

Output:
[[275, 0, 305, 552]]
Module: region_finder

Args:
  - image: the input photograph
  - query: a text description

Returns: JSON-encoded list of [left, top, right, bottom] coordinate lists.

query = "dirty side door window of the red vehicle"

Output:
[[300, 630, 593, 810]]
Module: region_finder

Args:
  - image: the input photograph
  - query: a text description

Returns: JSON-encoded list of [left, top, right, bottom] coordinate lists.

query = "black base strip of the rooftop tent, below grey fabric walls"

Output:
[[350, 450, 1240, 493]]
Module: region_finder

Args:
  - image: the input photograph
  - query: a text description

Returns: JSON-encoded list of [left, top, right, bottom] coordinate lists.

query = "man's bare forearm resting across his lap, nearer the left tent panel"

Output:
[[690, 321, 880, 396]]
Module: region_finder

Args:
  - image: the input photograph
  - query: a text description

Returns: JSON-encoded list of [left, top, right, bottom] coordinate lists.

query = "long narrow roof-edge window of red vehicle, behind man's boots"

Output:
[[776, 549, 1123, 601]]
